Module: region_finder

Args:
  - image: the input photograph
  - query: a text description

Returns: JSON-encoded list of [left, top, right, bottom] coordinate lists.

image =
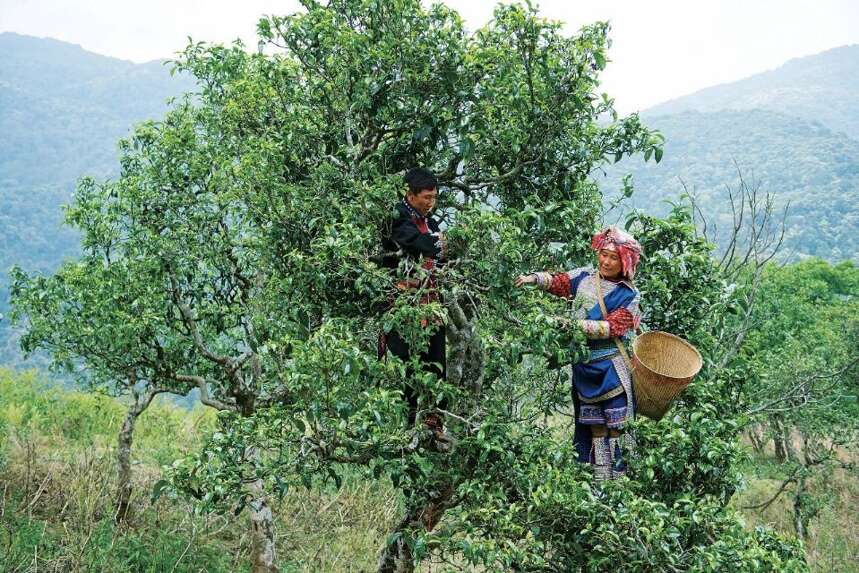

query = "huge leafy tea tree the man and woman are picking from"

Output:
[[10, 0, 803, 572]]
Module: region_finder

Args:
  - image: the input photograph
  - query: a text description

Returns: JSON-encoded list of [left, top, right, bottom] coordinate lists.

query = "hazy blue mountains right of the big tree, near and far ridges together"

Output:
[[601, 46, 859, 260]]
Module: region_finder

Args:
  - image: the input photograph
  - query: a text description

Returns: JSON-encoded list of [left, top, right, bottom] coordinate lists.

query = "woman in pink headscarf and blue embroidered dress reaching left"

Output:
[[515, 227, 641, 479]]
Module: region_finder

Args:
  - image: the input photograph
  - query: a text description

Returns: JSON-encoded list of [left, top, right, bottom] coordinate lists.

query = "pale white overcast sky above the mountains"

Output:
[[0, 0, 859, 113]]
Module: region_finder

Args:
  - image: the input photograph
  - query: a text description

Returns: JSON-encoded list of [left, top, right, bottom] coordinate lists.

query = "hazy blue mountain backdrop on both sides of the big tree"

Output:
[[0, 33, 859, 364]]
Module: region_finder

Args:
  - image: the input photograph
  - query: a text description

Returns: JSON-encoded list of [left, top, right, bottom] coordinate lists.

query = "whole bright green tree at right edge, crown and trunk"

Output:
[[743, 260, 859, 538]]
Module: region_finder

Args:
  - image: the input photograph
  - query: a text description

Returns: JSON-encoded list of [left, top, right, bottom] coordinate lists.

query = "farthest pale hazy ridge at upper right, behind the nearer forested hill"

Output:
[[645, 45, 859, 139]]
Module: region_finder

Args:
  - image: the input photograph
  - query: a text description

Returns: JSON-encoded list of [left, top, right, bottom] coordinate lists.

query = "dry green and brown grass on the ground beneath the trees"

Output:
[[0, 370, 859, 573]]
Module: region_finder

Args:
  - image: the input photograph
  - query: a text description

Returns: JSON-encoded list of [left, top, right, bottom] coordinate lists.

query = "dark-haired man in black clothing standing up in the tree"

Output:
[[379, 167, 447, 440]]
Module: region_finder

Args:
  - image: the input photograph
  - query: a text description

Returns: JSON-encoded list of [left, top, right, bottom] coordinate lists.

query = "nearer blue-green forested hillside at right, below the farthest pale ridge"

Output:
[[602, 109, 859, 260]]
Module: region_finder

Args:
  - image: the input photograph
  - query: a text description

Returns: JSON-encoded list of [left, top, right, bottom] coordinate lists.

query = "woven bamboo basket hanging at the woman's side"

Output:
[[632, 330, 703, 420]]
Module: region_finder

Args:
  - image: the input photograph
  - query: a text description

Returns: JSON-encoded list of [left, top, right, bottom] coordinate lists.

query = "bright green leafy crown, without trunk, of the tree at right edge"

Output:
[[744, 260, 859, 434]]
